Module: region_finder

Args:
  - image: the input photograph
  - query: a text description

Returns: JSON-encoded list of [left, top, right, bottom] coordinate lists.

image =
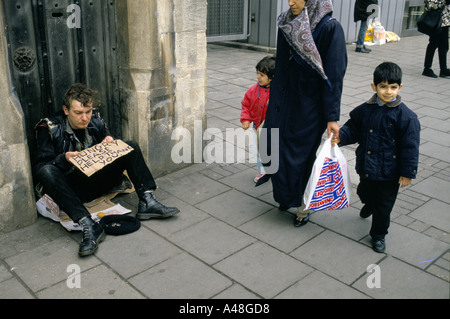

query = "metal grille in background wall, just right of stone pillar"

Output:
[[206, 0, 248, 42]]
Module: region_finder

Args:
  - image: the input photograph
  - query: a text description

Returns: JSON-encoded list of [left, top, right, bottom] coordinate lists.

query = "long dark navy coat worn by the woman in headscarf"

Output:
[[263, 17, 347, 207]]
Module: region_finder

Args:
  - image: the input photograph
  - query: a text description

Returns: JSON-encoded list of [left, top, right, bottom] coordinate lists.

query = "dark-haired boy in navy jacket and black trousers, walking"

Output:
[[332, 62, 420, 253]]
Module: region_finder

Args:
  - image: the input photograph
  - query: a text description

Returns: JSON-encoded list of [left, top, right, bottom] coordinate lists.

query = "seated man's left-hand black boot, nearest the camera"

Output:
[[78, 217, 106, 257]]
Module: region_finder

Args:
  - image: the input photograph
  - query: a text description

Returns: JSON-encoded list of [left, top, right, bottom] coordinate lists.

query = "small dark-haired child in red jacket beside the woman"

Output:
[[241, 56, 275, 183]]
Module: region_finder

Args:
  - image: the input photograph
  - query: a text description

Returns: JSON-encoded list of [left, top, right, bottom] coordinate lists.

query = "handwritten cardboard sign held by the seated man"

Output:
[[70, 140, 133, 176]]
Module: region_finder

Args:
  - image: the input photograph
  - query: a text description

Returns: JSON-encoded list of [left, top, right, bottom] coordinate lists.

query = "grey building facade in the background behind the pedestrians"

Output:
[[207, 0, 424, 48]]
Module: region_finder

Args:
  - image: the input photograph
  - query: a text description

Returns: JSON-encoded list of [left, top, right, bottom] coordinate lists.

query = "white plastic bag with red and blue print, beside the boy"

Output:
[[303, 137, 351, 211]]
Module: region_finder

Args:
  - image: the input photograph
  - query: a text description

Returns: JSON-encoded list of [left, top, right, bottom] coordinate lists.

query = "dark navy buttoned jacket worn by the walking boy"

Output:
[[339, 94, 420, 181]]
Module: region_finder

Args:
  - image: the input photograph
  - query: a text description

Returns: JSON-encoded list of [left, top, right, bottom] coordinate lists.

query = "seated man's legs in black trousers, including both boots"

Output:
[[37, 141, 179, 256]]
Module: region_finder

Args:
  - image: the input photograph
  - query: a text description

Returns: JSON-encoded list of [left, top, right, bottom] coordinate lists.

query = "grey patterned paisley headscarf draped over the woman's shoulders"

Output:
[[278, 0, 333, 80]]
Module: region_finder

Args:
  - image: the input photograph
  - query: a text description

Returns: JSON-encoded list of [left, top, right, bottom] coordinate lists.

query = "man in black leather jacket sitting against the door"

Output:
[[33, 84, 179, 256]]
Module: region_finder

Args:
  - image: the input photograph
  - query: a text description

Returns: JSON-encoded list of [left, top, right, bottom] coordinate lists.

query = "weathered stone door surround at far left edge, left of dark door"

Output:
[[0, 2, 36, 233]]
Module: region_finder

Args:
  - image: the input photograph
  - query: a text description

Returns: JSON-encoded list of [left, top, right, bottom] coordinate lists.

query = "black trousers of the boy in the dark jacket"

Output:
[[357, 178, 399, 240]]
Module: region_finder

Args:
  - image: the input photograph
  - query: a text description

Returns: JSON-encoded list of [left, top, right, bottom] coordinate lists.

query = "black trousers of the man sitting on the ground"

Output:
[[37, 141, 156, 222]]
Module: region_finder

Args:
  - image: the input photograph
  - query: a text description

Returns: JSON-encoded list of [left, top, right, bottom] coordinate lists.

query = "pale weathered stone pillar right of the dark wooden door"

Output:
[[117, 0, 207, 176]]
